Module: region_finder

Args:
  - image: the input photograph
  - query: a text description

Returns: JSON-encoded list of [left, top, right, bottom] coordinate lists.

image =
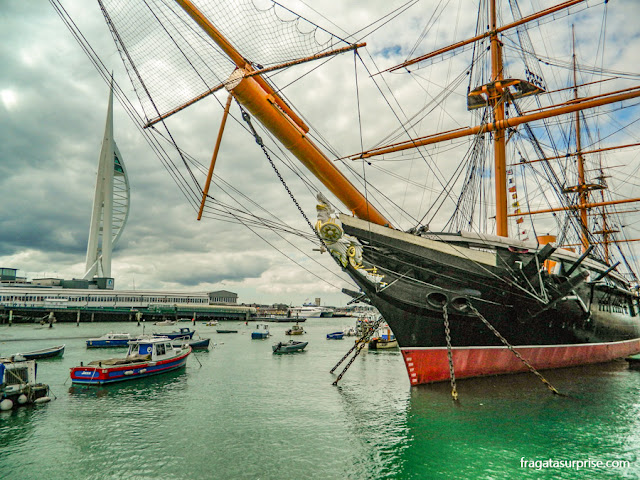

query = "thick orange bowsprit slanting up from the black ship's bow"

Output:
[[175, 0, 391, 226]]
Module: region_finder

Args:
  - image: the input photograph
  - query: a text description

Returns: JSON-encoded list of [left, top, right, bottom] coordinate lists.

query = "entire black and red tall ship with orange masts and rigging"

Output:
[[56, 0, 640, 385]]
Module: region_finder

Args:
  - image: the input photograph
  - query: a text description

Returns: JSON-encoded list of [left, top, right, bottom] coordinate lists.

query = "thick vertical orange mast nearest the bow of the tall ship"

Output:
[[488, 0, 509, 237]]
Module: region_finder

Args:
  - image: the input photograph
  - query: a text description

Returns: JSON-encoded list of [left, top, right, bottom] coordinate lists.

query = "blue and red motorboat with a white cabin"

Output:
[[71, 336, 191, 385]]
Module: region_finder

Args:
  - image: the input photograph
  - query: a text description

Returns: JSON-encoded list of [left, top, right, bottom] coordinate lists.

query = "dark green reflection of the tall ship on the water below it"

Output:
[[401, 362, 640, 479]]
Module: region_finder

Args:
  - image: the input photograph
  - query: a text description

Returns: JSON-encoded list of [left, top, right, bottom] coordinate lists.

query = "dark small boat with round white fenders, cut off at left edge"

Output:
[[0, 359, 51, 410]]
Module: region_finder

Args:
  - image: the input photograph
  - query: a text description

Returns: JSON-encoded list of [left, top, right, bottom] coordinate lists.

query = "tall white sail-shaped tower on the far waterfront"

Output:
[[83, 80, 129, 280]]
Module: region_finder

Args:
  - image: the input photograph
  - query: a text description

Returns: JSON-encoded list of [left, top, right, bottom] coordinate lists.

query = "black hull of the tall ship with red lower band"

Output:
[[342, 217, 640, 384]]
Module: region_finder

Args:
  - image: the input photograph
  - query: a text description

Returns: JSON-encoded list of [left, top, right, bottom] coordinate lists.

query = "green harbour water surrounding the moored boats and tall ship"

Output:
[[0, 318, 640, 480]]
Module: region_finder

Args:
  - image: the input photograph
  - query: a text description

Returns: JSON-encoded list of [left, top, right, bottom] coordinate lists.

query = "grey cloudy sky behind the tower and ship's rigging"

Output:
[[0, 0, 640, 305]]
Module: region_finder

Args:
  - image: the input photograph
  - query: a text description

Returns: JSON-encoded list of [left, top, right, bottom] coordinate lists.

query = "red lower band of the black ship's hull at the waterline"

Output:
[[402, 339, 640, 385]]
